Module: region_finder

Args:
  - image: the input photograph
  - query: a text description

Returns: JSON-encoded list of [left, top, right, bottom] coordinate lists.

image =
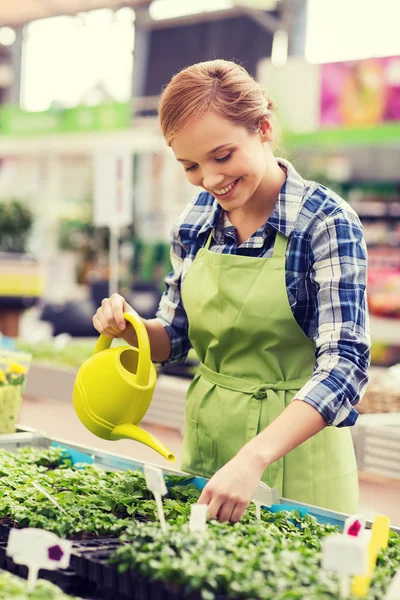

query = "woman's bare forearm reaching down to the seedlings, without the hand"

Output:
[[240, 400, 326, 468]]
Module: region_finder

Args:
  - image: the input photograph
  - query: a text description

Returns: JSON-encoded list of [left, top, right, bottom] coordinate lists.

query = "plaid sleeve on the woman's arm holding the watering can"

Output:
[[156, 219, 191, 364]]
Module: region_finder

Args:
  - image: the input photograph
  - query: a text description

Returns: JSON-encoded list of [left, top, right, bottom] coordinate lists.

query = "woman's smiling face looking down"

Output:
[[171, 111, 276, 212]]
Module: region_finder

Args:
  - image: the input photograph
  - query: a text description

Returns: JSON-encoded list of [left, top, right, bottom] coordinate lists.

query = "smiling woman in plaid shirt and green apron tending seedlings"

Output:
[[93, 60, 369, 521]]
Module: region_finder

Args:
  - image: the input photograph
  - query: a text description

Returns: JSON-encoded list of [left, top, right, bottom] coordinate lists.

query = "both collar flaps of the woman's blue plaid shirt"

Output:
[[197, 158, 306, 243]]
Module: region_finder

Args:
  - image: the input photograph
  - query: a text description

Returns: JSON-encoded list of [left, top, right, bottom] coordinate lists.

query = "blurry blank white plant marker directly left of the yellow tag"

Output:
[[322, 534, 368, 598]]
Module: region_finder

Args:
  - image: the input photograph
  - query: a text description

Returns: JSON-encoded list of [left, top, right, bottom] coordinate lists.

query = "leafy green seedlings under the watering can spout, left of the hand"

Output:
[[0, 448, 203, 538]]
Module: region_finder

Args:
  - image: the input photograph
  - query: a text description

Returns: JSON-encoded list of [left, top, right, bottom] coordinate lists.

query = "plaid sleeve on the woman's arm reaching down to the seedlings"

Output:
[[296, 211, 370, 427]]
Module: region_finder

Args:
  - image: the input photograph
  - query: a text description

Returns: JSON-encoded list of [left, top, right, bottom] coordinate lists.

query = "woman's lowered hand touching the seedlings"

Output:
[[198, 446, 265, 522]]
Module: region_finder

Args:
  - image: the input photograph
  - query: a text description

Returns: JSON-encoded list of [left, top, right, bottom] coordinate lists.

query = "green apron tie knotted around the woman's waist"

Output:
[[199, 363, 309, 398]]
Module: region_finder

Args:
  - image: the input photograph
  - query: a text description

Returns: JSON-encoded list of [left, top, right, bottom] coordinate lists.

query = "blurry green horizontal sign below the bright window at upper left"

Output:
[[0, 102, 132, 136]]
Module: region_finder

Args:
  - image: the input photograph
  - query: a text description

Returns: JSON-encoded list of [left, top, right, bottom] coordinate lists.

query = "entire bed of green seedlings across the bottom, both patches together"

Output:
[[0, 448, 400, 600]]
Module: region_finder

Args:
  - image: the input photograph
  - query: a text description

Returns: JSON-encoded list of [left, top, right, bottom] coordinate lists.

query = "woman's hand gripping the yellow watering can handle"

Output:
[[92, 294, 140, 339]]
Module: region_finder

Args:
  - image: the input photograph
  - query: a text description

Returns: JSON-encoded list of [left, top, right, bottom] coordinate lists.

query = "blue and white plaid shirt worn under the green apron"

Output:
[[157, 158, 370, 427]]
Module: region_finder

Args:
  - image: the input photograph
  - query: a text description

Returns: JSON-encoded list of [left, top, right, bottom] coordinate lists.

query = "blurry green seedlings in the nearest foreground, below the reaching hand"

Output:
[[111, 511, 400, 600]]
